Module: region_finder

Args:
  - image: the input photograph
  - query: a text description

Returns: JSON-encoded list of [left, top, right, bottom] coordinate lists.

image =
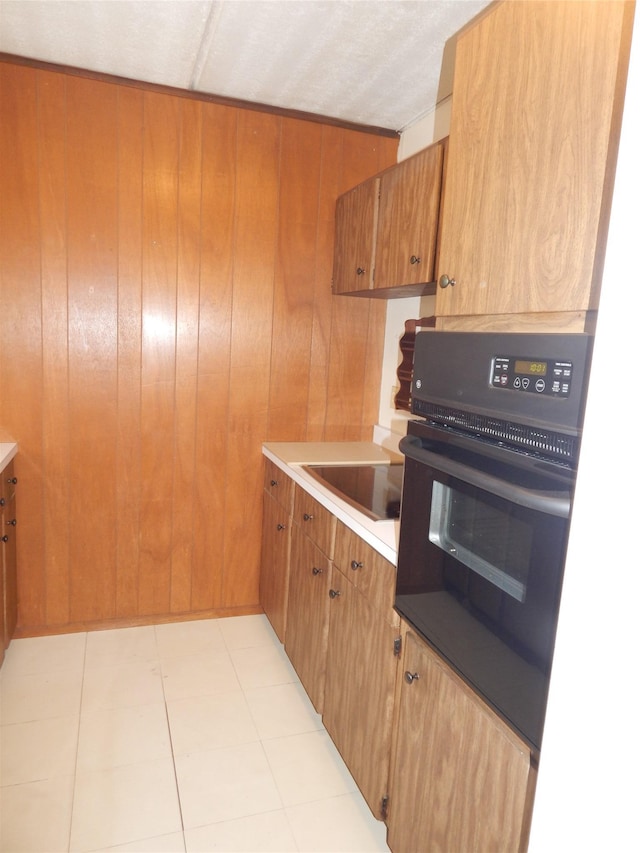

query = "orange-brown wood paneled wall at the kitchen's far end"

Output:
[[0, 62, 397, 635]]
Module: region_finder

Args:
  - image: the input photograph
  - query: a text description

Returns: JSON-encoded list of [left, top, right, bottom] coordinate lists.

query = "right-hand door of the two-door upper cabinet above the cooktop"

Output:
[[374, 143, 443, 290]]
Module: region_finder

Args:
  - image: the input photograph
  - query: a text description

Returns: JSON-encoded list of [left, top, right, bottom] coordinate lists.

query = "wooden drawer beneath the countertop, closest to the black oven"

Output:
[[334, 521, 400, 626]]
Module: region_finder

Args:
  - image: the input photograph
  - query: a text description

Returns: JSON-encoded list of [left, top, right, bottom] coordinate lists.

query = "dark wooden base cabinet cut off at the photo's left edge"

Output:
[[0, 462, 18, 662]]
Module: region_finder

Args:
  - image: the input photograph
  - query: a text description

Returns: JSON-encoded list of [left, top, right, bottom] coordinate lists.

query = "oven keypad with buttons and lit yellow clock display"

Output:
[[490, 355, 573, 397]]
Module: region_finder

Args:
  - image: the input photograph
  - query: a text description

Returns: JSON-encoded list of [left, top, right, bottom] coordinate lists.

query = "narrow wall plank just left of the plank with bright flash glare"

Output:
[[115, 87, 143, 617]]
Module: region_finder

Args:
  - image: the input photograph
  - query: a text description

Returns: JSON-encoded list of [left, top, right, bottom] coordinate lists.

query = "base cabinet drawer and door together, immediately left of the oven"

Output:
[[323, 522, 399, 819]]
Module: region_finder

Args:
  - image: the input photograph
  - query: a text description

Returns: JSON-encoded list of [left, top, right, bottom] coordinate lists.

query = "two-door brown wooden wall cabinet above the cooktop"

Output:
[[333, 143, 444, 298]]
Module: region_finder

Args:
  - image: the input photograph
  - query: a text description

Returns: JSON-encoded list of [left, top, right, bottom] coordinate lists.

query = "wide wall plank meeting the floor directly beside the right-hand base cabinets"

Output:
[[223, 111, 282, 607]]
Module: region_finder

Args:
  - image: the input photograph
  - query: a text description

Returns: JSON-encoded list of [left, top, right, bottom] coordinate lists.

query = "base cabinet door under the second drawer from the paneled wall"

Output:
[[285, 524, 331, 714]]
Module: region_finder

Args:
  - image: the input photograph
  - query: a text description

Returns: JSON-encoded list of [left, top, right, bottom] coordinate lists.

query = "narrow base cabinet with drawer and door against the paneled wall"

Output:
[[260, 459, 294, 643]]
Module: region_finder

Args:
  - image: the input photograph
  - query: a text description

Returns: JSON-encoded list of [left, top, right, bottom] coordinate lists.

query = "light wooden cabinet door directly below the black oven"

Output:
[[387, 631, 535, 853]]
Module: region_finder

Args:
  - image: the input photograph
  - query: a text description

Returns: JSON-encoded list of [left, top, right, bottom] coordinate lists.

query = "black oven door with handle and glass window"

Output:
[[396, 427, 571, 749]]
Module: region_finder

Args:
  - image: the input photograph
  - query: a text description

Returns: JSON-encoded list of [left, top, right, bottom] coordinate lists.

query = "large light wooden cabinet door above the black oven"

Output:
[[436, 0, 633, 316]]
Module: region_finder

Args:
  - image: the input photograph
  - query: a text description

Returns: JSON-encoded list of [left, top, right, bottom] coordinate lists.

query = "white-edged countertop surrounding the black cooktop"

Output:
[[262, 441, 403, 566]]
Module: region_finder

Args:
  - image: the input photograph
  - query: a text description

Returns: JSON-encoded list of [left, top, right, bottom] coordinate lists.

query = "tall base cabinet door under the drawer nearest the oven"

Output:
[[323, 572, 397, 818]]
